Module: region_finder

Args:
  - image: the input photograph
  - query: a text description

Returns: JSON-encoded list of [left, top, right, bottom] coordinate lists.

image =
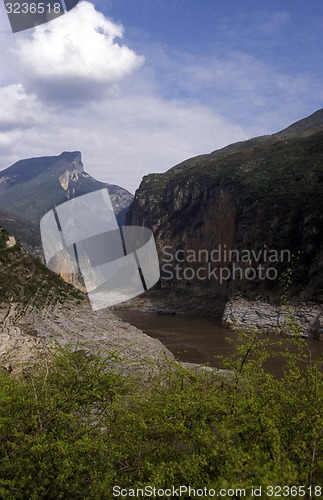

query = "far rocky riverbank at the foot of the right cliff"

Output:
[[113, 289, 323, 340]]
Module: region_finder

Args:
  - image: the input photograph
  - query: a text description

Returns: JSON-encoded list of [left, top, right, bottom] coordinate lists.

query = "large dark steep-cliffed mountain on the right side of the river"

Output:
[[126, 109, 323, 304]]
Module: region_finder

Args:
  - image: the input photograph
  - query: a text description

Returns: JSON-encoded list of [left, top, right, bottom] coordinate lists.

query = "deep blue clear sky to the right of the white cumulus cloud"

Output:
[[100, 0, 323, 125]]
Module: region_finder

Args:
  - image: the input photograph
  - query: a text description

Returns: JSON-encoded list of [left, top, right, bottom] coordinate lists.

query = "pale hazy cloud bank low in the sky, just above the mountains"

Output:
[[0, 90, 246, 192]]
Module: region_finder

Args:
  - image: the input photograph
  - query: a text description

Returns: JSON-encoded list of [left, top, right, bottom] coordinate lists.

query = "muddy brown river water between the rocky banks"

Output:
[[115, 311, 323, 374]]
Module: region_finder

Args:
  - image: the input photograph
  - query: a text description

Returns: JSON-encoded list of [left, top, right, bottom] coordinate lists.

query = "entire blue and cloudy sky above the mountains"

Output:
[[0, 0, 323, 193]]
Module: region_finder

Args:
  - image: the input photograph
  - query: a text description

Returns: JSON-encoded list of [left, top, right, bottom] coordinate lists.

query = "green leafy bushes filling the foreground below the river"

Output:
[[0, 334, 323, 500]]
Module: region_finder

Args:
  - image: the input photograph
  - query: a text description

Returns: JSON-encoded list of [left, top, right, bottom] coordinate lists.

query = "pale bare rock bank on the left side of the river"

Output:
[[0, 302, 174, 373]]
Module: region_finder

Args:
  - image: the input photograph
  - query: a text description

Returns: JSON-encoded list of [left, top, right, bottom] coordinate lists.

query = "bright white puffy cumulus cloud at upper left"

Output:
[[15, 1, 144, 104]]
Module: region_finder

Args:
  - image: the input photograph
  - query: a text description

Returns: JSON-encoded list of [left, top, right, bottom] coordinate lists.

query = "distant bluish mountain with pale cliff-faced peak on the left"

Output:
[[0, 151, 133, 254]]
